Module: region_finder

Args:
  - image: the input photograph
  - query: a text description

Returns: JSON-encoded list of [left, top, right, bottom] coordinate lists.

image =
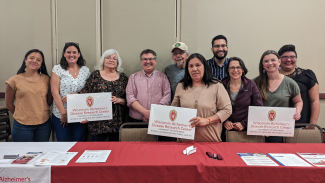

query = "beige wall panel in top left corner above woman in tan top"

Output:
[[0, 0, 52, 92]]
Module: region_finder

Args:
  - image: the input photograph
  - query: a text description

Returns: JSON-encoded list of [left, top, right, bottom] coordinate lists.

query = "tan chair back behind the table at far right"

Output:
[[283, 123, 323, 143]]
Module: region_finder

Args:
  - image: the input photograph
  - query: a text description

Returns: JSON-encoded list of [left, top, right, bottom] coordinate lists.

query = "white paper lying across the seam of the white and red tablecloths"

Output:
[[35, 151, 78, 166]]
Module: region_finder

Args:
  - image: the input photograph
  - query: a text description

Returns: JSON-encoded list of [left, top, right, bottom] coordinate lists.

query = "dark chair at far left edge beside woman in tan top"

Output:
[[0, 106, 11, 142]]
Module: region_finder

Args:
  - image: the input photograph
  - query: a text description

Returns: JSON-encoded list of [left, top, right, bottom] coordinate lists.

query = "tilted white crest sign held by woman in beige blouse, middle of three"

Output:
[[148, 104, 197, 140]]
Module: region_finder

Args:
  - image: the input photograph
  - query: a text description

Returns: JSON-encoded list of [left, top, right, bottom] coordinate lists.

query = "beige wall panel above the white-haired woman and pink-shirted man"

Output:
[[103, 0, 176, 76]]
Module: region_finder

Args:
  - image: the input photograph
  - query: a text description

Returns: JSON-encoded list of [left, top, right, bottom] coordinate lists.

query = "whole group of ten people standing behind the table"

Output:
[[6, 35, 320, 142]]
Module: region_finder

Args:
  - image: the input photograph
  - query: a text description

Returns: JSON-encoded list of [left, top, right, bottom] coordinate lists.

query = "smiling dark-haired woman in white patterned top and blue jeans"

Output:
[[51, 42, 90, 142]]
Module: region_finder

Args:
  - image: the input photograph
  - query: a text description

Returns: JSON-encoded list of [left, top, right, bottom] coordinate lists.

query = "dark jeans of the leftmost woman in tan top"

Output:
[[11, 118, 52, 142]]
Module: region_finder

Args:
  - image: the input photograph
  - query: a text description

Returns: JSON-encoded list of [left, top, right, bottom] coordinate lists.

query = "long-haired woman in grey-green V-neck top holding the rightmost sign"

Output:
[[255, 50, 303, 142]]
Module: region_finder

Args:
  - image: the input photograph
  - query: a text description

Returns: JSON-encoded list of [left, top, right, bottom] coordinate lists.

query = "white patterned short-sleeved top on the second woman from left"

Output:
[[52, 64, 90, 118]]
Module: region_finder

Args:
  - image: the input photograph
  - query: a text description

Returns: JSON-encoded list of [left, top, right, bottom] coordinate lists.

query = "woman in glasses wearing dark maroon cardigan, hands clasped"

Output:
[[222, 57, 263, 134]]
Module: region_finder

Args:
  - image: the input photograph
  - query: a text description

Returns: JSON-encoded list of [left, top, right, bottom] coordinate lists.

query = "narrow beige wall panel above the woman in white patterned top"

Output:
[[57, 0, 96, 71]]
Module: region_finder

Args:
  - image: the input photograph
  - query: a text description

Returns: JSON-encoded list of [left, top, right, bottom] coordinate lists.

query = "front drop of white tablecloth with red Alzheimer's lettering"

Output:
[[0, 166, 51, 183]]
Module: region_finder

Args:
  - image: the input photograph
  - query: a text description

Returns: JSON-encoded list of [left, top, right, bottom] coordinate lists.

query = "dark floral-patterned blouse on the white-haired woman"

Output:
[[80, 70, 128, 135]]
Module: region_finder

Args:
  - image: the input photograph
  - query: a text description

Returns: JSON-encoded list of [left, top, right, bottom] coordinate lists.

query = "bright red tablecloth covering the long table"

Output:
[[51, 142, 325, 183]]
